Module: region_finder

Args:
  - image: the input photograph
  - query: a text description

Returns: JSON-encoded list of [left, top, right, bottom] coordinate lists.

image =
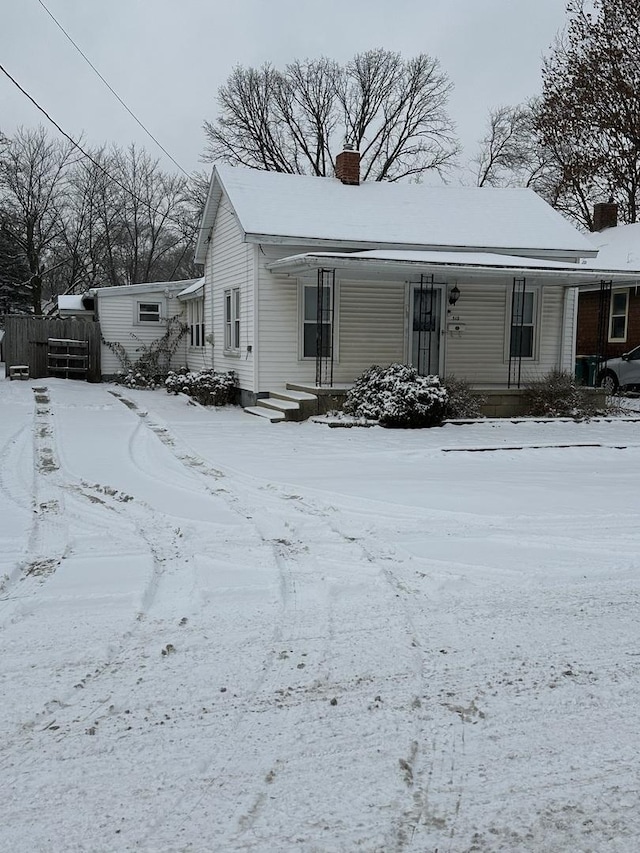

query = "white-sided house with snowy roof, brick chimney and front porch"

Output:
[[196, 151, 636, 418]]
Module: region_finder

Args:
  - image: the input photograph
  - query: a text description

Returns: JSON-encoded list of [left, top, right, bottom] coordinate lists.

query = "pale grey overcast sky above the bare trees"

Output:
[[0, 0, 565, 181]]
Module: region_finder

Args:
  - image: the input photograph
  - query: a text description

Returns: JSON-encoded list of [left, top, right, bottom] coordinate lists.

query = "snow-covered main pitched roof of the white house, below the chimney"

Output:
[[196, 165, 595, 263]]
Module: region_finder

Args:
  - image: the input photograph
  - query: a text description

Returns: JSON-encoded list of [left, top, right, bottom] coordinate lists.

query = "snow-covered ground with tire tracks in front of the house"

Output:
[[0, 379, 640, 853]]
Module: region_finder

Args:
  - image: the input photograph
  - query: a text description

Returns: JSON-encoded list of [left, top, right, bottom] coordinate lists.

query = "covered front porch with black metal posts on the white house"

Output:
[[267, 251, 629, 402]]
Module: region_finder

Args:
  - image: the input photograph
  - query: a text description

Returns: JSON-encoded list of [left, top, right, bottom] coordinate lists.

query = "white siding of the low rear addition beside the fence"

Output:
[[98, 292, 187, 376]]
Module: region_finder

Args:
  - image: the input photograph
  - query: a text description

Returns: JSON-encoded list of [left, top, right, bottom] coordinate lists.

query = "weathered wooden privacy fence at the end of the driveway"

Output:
[[3, 314, 101, 382]]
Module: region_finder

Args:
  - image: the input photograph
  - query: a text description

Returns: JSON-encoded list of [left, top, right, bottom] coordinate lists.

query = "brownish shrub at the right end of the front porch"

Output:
[[524, 370, 602, 418]]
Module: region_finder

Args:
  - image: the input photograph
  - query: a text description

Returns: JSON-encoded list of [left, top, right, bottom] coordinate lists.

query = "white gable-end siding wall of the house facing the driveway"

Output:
[[203, 198, 255, 391]]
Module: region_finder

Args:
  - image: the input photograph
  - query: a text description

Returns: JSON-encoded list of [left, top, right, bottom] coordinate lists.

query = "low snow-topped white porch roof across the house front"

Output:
[[267, 251, 640, 287]]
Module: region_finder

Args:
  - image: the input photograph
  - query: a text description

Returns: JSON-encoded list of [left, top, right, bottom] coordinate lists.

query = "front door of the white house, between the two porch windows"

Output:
[[409, 283, 444, 376]]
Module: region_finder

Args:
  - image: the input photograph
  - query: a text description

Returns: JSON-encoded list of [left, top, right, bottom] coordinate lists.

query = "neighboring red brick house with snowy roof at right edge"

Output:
[[576, 203, 640, 378]]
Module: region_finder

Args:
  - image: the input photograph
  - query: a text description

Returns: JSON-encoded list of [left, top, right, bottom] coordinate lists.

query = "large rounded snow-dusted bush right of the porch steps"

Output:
[[343, 364, 447, 427]]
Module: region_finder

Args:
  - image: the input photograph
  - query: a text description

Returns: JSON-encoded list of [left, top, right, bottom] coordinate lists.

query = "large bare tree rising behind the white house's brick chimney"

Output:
[[204, 50, 459, 181]]
